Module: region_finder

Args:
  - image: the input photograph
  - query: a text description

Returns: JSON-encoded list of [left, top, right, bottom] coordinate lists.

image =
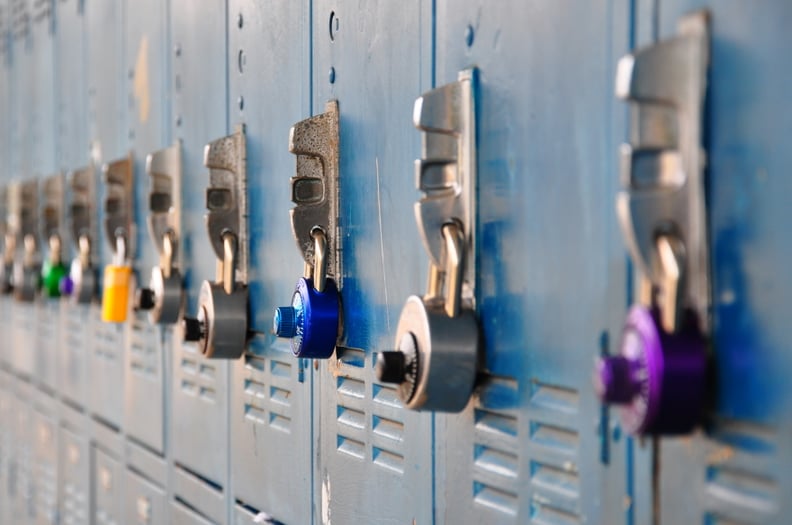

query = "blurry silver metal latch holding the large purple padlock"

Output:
[[616, 11, 710, 333]]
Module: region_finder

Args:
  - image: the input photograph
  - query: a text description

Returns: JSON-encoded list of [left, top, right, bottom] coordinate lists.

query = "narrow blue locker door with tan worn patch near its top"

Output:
[[124, 0, 171, 454]]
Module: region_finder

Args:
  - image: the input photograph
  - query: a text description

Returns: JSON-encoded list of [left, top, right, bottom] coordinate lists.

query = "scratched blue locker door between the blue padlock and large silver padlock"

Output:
[[313, 1, 433, 522]]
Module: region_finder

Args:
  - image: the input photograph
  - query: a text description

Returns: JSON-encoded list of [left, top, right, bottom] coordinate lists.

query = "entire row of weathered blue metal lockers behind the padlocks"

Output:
[[0, 0, 792, 524]]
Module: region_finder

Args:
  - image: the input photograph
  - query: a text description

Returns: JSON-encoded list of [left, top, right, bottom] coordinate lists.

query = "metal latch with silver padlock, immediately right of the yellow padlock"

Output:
[[135, 142, 184, 324]]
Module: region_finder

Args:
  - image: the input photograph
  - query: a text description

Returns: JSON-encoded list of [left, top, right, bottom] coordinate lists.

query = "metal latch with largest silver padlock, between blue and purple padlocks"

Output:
[[376, 69, 481, 412]]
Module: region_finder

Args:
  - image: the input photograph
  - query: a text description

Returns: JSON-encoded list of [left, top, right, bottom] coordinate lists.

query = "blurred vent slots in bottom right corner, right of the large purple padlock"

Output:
[[704, 422, 779, 525]]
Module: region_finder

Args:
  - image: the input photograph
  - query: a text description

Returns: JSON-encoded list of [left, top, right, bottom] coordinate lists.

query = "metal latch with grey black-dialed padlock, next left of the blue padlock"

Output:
[[183, 126, 248, 359]]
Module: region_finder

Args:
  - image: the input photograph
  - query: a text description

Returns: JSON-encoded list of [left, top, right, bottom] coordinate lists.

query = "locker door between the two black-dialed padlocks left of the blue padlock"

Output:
[[169, 0, 230, 489]]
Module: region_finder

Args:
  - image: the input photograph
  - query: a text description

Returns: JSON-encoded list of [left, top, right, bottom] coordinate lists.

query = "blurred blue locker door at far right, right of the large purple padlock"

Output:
[[657, 0, 792, 524]]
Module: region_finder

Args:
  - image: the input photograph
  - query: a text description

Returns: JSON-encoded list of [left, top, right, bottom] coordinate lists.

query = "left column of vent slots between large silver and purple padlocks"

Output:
[[472, 376, 520, 517]]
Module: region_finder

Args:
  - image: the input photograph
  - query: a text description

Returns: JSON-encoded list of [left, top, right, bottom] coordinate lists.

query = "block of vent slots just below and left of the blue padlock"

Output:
[[241, 354, 292, 433]]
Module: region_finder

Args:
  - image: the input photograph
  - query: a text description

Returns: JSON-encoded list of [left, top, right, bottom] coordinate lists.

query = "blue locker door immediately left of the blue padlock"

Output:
[[226, 0, 314, 523]]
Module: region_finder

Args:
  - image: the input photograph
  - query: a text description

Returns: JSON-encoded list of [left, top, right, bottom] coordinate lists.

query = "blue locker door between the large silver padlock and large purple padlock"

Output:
[[435, 1, 641, 523]]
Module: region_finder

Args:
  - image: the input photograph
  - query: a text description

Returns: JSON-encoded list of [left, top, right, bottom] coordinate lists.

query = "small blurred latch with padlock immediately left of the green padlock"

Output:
[[14, 180, 41, 302]]
